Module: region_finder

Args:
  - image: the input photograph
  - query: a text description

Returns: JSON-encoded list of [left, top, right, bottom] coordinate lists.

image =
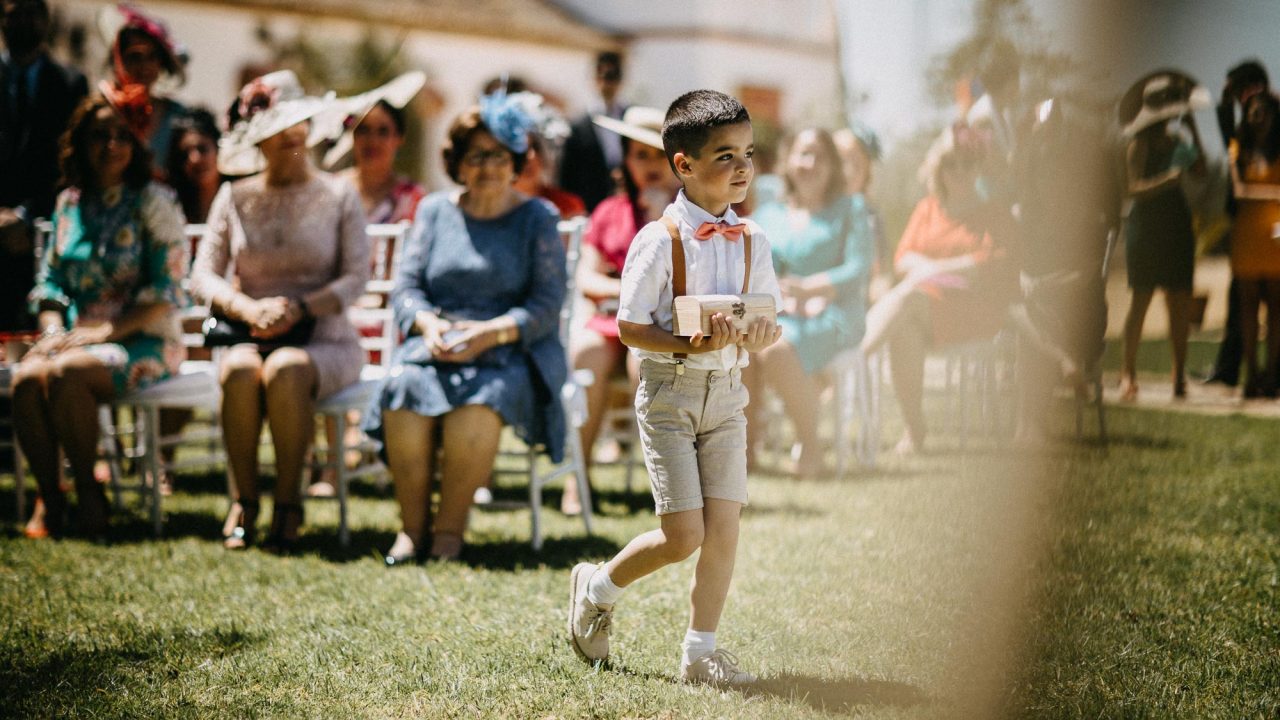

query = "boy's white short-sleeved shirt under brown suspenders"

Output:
[[618, 190, 782, 370]]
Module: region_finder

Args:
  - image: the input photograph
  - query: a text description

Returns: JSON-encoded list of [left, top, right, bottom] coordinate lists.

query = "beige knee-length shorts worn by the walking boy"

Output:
[[636, 360, 748, 515]]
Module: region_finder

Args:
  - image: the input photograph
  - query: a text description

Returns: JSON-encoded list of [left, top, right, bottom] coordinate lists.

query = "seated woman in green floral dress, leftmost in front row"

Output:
[[13, 99, 187, 536]]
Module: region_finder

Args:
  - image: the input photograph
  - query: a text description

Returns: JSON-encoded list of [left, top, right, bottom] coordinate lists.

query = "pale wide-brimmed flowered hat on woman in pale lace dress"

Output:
[[218, 70, 334, 176]]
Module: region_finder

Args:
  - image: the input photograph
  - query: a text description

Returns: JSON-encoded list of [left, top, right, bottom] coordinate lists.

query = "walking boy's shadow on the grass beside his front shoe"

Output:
[[739, 674, 929, 714]]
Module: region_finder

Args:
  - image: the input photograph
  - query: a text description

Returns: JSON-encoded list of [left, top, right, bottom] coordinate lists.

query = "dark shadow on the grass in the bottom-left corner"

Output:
[[0, 620, 265, 717]]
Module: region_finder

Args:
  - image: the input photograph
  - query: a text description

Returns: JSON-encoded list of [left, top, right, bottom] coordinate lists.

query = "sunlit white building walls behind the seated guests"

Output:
[[54, 0, 838, 181]]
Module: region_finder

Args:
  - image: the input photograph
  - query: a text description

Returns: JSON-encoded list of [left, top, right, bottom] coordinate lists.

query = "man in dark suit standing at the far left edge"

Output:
[[0, 0, 88, 331]]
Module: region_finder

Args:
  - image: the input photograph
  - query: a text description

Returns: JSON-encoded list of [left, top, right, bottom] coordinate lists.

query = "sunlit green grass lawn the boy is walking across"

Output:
[[0, 399, 1280, 719]]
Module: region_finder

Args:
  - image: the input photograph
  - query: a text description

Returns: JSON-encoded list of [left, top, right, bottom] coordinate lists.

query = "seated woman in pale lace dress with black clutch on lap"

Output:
[[192, 70, 369, 551]]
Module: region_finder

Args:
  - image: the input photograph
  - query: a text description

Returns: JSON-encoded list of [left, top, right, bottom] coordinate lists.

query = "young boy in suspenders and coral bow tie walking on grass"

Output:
[[568, 90, 782, 685]]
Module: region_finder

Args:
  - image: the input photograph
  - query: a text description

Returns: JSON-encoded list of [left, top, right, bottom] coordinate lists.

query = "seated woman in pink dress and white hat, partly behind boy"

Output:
[[561, 108, 680, 515]]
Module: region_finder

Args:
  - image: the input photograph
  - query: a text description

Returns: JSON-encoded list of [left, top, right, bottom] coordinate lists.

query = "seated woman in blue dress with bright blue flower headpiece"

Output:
[[364, 94, 567, 565]]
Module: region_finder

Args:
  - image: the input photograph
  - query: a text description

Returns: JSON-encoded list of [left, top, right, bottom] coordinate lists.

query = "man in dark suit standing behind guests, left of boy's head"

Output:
[[559, 53, 627, 213]]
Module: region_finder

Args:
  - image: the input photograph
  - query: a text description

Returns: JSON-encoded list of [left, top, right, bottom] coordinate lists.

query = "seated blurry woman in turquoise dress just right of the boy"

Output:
[[746, 129, 876, 477]]
